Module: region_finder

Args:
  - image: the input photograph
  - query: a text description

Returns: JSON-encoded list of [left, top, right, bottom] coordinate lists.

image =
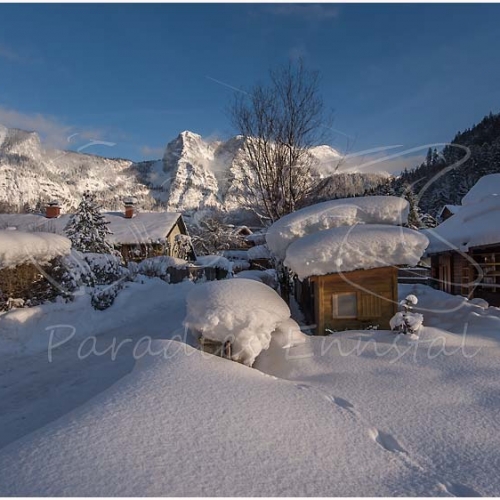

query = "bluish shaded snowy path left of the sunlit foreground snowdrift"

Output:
[[0, 286, 192, 448]]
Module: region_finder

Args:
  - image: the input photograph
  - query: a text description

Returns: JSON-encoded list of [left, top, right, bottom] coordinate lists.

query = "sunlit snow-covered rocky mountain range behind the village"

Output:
[[0, 126, 386, 220]]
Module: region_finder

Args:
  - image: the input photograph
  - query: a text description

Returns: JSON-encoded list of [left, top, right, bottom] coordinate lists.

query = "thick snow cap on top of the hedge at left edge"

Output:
[[0, 229, 71, 269]]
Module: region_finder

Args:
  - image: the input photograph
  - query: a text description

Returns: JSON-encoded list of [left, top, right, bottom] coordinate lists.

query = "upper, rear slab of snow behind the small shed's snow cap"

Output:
[[266, 196, 409, 259]]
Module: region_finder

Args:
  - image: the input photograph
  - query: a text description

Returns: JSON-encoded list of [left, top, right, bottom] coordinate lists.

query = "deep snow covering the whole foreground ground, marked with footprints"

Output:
[[0, 280, 500, 496]]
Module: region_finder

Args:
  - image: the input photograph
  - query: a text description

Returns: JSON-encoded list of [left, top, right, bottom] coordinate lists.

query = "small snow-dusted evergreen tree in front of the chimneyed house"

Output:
[[65, 191, 116, 254]]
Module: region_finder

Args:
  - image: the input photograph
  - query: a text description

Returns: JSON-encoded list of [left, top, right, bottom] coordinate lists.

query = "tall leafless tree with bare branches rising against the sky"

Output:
[[230, 61, 328, 222]]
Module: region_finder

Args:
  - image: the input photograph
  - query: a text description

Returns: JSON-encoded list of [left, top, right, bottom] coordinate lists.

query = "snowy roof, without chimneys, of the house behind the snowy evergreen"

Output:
[[0, 212, 181, 244]]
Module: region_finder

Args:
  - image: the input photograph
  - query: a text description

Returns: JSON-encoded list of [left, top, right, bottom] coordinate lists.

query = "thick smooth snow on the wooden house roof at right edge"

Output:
[[425, 174, 500, 254]]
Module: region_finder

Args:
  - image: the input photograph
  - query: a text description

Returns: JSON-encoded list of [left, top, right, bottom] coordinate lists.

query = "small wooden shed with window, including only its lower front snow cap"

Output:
[[284, 224, 428, 334]]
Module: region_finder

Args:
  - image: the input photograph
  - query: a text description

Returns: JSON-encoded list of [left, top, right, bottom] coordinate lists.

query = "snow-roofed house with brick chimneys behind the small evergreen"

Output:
[[0, 200, 195, 262]]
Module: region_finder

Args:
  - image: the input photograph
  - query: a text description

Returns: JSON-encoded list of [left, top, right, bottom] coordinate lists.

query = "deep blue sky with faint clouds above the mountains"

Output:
[[0, 4, 500, 170]]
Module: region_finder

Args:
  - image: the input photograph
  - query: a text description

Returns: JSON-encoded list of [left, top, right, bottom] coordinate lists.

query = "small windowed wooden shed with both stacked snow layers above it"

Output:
[[267, 196, 428, 335]]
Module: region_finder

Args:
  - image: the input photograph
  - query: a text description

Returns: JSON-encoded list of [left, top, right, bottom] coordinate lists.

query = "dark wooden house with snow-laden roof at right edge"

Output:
[[426, 174, 500, 306]]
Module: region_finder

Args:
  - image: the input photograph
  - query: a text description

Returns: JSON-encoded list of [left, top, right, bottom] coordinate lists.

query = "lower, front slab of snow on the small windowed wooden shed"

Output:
[[284, 224, 429, 279]]
